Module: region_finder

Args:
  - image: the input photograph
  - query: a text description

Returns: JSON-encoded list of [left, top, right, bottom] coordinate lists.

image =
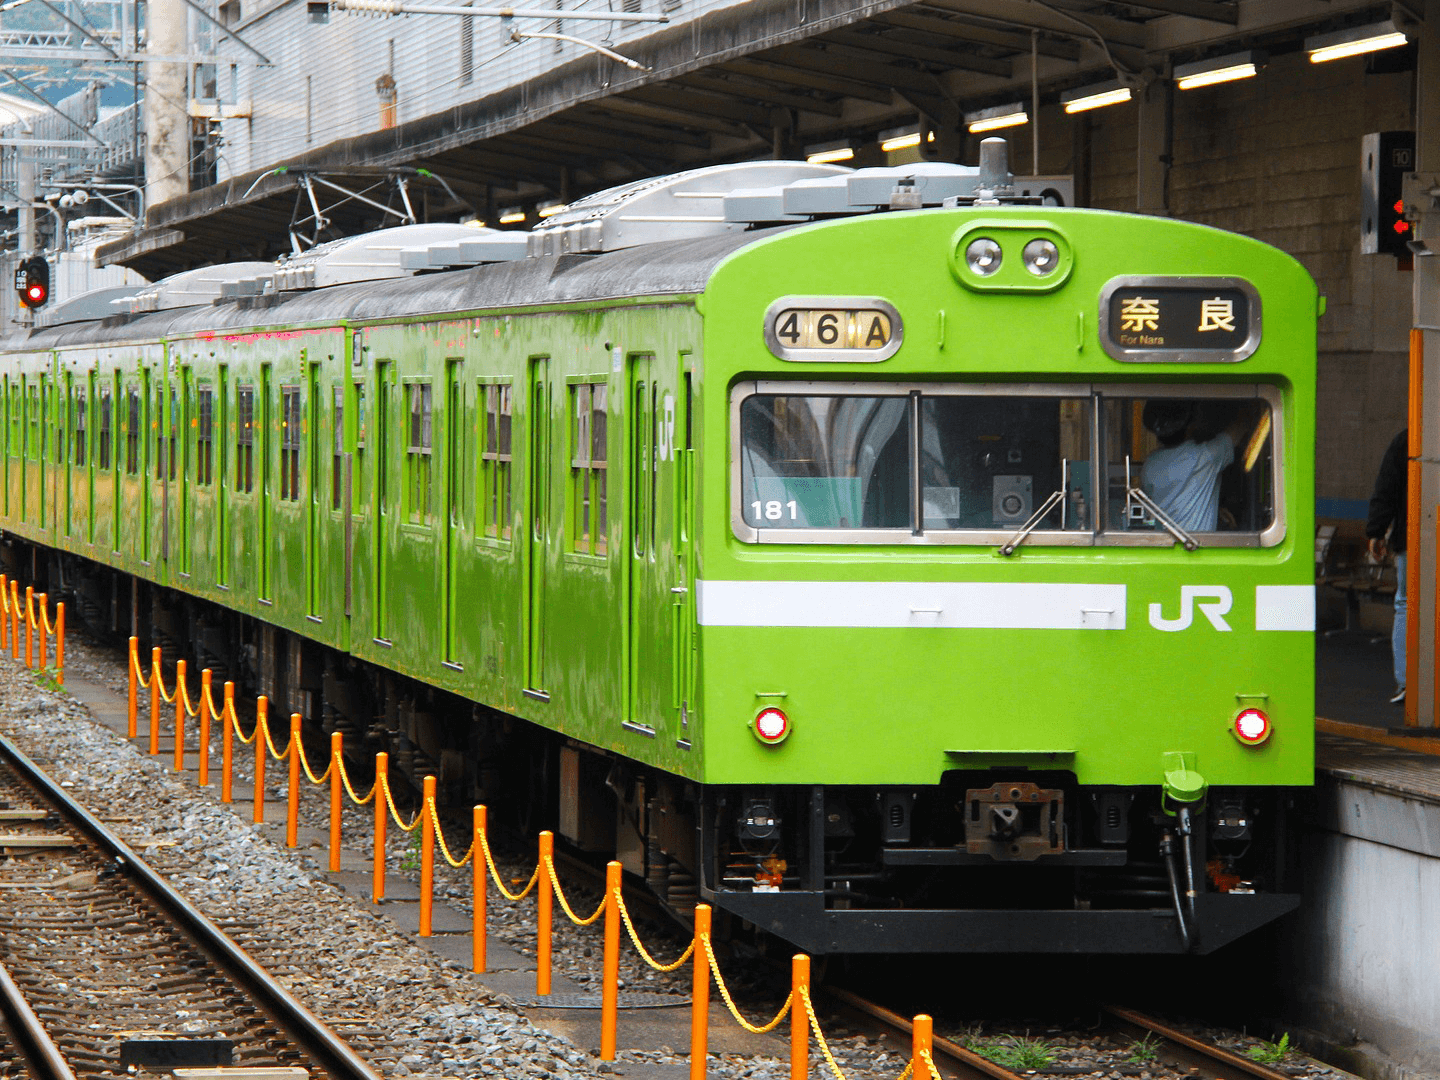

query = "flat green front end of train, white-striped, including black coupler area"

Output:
[[697, 188, 1318, 953]]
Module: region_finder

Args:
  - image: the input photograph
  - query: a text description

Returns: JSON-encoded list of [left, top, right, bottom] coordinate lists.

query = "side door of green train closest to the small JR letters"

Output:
[[622, 353, 667, 734]]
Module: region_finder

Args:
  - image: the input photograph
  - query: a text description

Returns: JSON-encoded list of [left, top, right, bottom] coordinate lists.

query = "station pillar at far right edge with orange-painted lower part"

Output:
[[1405, 0, 1440, 727]]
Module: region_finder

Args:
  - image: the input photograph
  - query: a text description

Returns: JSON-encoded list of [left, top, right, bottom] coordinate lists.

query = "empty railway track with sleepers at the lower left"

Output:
[[0, 737, 379, 1080]]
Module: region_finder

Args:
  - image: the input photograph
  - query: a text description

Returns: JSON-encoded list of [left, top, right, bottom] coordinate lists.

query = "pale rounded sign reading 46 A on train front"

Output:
[[765, 297, 901, 363]]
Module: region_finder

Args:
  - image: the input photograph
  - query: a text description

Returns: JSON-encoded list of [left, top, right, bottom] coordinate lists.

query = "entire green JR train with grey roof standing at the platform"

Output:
[[0, 143, 1320, 953]]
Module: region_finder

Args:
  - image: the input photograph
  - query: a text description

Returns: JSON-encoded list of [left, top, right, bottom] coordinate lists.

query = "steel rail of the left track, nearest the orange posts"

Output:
[[0, 736, 382, 1080]]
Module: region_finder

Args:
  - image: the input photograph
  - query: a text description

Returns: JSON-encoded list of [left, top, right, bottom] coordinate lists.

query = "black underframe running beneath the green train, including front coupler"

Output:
[[16, 536, 1299, 955]]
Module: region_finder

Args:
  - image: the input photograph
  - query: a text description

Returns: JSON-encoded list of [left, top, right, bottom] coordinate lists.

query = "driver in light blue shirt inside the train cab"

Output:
[[1140, 397, 1264, 533]]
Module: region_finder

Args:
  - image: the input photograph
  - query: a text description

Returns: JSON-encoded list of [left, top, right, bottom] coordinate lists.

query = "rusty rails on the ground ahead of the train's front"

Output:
[[821, 986, 1293, 1080]]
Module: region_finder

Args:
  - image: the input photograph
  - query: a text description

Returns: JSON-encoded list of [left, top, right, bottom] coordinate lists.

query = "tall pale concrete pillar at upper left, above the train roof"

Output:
[[143, 0, 190, 210]]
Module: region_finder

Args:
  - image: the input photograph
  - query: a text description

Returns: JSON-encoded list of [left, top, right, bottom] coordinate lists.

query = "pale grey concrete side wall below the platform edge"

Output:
[[1287, 779, 1440, 1080]]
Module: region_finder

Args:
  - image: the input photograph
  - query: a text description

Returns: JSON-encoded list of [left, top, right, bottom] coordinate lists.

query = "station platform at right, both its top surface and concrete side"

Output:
[[1284, 632, 1440, 1080]]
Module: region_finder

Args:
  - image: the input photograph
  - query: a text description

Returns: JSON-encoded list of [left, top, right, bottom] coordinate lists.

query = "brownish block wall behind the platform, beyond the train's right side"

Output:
[[1065, 53, 1414, 517]]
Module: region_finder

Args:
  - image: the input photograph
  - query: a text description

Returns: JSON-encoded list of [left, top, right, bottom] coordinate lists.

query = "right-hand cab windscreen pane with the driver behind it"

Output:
[[1104, 387, 1277, 544]]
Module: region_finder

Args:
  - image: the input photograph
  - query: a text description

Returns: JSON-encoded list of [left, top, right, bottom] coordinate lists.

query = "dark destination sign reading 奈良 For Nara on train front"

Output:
[[1100, 278, 1260, 363]]
